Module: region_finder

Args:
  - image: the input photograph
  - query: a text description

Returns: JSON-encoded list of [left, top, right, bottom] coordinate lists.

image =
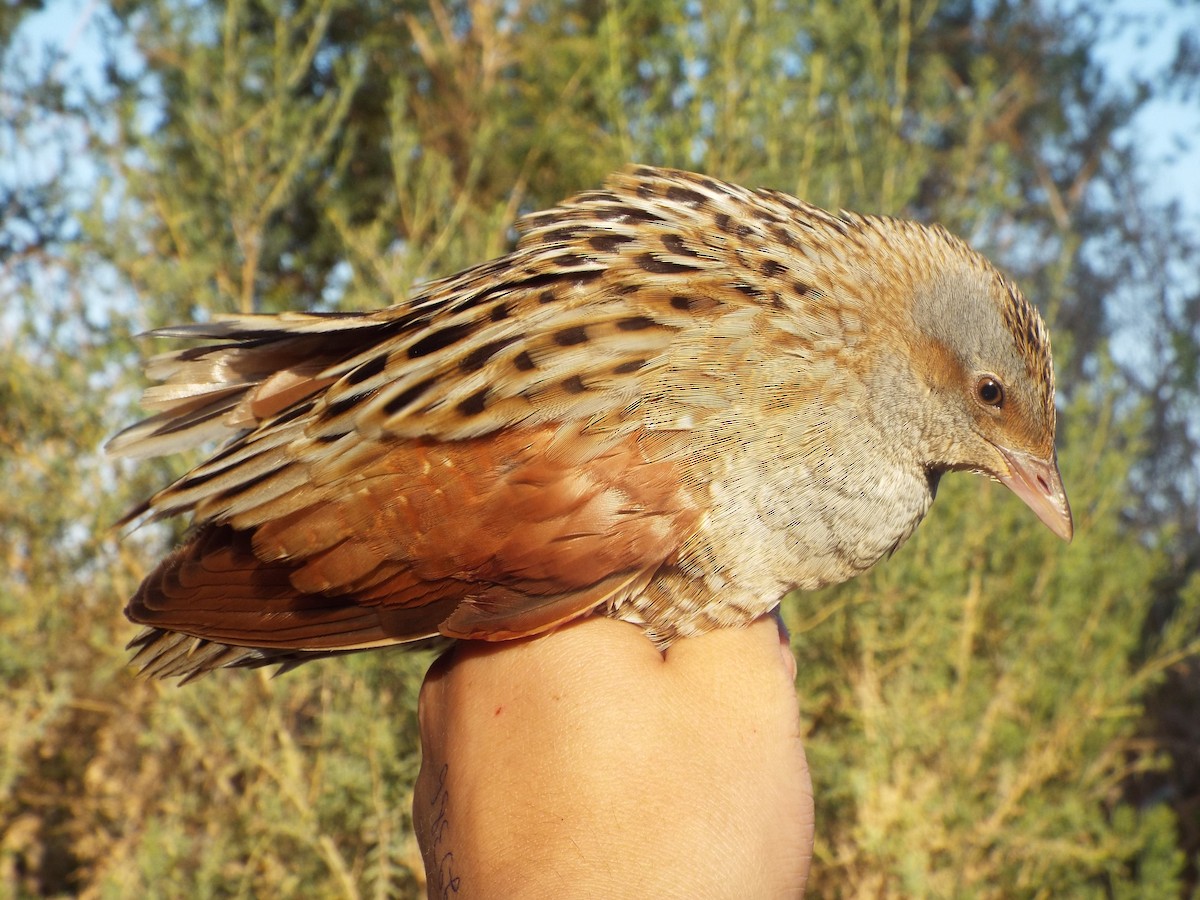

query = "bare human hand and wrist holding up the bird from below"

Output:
[[413, 617, 812, 898]]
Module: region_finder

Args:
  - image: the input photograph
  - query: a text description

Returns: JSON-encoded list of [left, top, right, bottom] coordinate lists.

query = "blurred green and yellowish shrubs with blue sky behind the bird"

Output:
[[0, 0, 1200, 898]]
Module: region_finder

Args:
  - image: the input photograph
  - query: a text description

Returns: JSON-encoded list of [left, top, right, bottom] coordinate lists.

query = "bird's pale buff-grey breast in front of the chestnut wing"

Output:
[[618, 426, 934, 638]]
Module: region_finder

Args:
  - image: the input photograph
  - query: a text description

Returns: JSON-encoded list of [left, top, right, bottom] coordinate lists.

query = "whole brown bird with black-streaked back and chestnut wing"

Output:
[[107, 166, 1073, 680]]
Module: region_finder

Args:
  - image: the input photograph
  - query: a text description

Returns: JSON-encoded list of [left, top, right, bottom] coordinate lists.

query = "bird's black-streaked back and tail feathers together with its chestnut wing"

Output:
[[108, 169, 844, 673]]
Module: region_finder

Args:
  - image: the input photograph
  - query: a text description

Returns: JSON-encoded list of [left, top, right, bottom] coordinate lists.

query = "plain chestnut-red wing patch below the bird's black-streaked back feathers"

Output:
[[127, 426, 700, 650]]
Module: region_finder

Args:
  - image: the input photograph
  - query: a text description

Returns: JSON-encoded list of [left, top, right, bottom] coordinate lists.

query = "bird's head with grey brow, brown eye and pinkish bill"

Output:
[[914, 265, 1074, 541]]
